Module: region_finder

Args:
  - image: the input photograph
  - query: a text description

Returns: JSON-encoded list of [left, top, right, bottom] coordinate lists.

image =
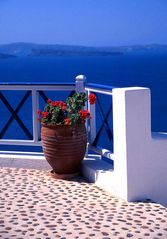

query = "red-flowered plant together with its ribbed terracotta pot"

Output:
[[37, 92, 96, 178]]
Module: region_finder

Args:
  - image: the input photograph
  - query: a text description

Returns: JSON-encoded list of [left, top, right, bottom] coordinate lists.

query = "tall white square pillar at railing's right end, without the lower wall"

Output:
[[113, 87, 152, 201]]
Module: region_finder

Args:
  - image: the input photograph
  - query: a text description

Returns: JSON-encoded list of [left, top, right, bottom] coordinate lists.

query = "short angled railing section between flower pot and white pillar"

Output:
[[85, 83, 114, 160]]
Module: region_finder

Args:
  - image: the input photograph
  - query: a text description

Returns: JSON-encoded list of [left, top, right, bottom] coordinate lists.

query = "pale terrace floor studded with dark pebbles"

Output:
[[0, 167, 167, 239]]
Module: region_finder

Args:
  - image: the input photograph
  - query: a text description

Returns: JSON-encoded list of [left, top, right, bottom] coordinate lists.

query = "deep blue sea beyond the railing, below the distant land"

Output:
[[0, 52, 167, 151]]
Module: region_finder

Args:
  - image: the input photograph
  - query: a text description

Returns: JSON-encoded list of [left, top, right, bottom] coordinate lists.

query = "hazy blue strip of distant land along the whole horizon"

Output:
[[0, 42, 167, 59]]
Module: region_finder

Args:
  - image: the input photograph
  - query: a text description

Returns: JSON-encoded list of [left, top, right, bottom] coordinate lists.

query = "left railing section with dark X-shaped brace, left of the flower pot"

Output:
[[0, 83, 76, 146]]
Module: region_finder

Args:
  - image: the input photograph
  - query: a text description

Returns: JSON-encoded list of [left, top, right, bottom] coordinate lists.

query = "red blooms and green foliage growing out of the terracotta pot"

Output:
[[37, 92, 91, 125]]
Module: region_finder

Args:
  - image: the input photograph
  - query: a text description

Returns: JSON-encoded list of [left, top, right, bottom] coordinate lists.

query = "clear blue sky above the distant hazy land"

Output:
[[0, 0, 167, 46]]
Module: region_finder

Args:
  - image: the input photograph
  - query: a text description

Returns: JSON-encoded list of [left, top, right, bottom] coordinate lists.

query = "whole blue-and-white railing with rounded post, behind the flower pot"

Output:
[[0, 76, 113, 159]]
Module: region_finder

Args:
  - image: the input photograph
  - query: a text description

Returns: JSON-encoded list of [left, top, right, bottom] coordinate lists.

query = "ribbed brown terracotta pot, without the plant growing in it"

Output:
[[41, 124, 87, 174]]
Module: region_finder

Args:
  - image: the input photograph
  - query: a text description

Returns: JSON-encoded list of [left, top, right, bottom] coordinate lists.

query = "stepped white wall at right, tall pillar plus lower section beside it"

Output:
[[113, 87, 167, 205]]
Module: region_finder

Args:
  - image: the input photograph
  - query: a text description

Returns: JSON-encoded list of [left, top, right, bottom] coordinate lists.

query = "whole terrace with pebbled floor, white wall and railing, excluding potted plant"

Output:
[[0, 76, 167, 239]]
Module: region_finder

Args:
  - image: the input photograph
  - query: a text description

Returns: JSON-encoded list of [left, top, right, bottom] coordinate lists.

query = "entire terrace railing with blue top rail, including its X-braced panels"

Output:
[[0, 77, 113, 159]]
